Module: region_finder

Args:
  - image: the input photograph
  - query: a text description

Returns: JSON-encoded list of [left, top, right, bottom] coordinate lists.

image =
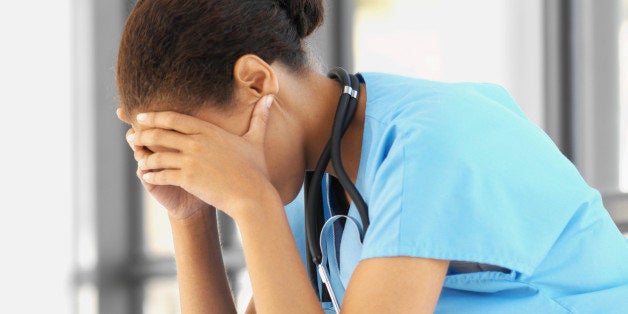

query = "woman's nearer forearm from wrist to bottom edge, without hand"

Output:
[[236, 197, 322, 313]]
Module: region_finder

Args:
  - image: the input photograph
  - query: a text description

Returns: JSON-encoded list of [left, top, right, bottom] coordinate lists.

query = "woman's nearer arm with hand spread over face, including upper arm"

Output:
[[135, 98, 447, 313]]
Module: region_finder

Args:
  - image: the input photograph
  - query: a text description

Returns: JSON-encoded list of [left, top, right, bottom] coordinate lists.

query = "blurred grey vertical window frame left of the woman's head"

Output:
[[72, 0, 142, 314]]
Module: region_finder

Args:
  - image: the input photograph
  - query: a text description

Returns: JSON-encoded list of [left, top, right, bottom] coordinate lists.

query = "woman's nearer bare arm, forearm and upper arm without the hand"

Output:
[[236, 193, 449, 313]]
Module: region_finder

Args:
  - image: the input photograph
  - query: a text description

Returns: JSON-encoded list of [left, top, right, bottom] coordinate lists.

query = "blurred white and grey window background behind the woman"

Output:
[[0, 0, 628, 314]]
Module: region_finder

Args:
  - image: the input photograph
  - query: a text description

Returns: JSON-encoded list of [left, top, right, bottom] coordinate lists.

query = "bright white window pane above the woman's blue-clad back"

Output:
[[354, 0, 544, 125]]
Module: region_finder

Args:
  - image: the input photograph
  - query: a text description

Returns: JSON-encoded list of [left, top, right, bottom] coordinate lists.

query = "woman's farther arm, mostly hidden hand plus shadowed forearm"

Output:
[[116, 109, 236, 313]]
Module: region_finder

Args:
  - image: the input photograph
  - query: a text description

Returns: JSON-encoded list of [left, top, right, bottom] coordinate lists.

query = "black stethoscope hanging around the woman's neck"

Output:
[[305, 68, 369, 311]]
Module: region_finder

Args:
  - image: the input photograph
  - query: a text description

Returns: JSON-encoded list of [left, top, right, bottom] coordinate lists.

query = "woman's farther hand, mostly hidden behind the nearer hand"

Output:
[[116, 109, 208, 219]]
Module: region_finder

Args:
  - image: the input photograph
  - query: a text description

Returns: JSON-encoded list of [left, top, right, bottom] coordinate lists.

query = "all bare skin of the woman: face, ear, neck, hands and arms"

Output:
[[118, 55, 449, 313]]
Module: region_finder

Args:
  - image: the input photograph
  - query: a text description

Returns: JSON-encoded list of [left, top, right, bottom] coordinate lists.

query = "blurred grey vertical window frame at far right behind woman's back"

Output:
[[562, 0, 628, 233]]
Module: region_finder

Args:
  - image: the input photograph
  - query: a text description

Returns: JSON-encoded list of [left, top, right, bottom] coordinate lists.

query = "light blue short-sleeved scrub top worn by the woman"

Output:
[[286, 73, 628, 313]]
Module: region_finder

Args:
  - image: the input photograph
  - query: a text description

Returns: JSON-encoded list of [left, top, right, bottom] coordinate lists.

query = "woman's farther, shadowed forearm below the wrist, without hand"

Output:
[[170, 208, 236, 314]]
